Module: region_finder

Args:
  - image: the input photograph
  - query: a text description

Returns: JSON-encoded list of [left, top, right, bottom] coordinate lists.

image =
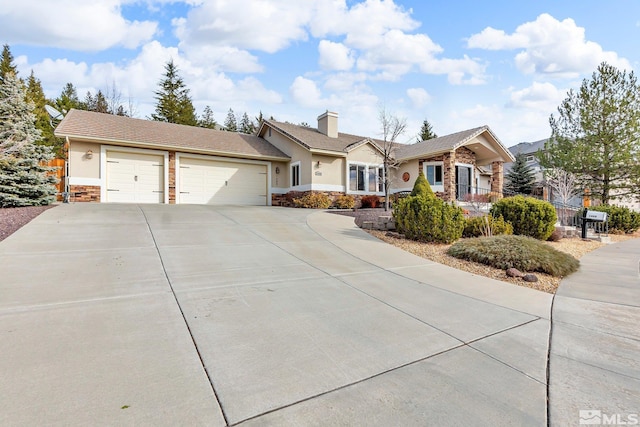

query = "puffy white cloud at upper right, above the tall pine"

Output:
[[467, 13, 631, 77]]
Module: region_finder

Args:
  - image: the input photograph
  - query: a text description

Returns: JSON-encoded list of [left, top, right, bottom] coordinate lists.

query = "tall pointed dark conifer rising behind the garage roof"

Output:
[[151, 60, 198, 126]]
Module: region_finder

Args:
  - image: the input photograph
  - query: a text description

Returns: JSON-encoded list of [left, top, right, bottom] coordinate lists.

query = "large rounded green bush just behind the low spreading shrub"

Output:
[[491, 196, 558, 240]]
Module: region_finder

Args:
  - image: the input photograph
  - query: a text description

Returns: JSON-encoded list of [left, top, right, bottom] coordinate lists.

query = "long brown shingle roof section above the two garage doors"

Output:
[[55, 110, 289, 160]]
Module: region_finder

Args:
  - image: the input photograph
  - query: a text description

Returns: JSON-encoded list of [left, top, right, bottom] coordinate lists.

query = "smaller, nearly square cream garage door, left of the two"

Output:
[[106, 151, 164, 203]]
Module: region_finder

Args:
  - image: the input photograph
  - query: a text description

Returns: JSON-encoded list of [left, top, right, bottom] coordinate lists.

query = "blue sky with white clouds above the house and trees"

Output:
[[0, 0, 640, 146]]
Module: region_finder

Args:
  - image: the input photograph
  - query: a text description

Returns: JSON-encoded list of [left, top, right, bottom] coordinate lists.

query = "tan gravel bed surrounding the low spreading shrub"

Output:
[[367, 230, 640, 293]]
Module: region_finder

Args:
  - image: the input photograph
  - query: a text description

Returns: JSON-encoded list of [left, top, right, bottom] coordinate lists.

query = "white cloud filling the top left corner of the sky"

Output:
[[0, 0, 158, 51]]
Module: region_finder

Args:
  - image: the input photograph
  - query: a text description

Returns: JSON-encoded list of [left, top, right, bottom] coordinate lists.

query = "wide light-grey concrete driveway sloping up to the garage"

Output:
[[0, 204, 551, 426]]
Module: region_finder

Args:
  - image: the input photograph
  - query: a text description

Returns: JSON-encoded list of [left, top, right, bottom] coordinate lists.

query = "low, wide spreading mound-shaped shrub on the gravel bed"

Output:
[[447, 235, 580, 277]]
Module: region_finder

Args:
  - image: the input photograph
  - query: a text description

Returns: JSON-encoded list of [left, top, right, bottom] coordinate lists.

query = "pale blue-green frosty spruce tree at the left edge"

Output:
[[0, 73, 56, 208]]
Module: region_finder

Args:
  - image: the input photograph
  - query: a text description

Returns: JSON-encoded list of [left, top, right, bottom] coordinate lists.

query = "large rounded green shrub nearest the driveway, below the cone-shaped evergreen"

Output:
[[393, 195, 464, 243]]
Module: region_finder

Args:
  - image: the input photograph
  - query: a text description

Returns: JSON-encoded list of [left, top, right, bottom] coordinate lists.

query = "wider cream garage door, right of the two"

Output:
[[179, 158, 267, 206]]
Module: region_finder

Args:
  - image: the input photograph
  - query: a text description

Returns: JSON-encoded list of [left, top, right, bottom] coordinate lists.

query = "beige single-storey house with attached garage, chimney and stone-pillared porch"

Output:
[[55, 110, 514, 205]]
